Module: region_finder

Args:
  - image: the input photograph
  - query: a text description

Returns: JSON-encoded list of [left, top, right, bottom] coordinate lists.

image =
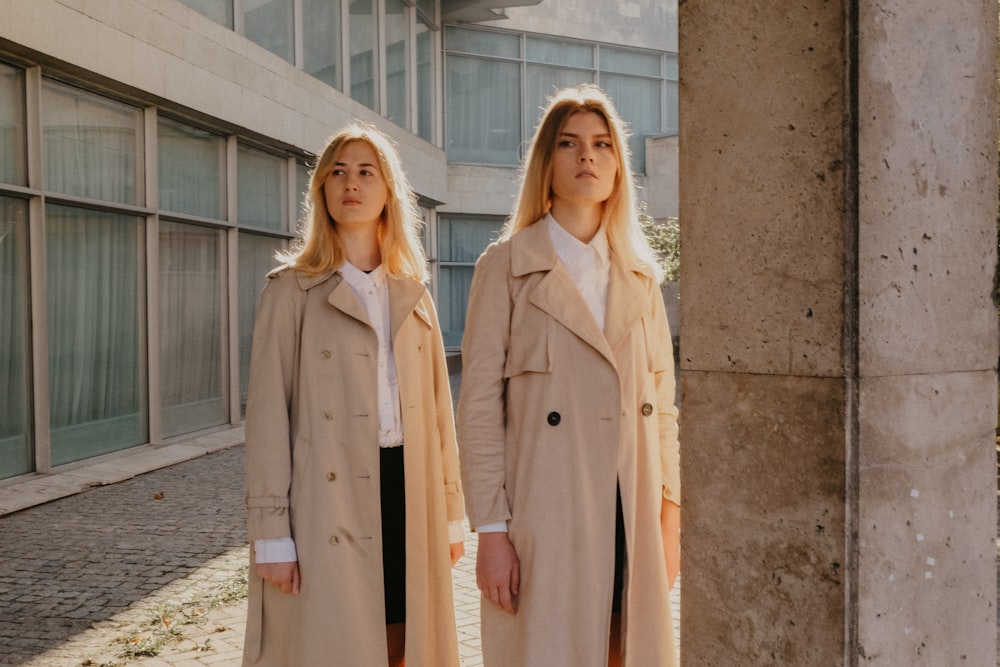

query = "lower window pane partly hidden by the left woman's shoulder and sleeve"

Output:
[[238, 233, 285, 414]]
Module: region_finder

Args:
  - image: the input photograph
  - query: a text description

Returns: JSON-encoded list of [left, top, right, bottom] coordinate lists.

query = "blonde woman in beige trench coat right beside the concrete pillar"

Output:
[[458, 85, 680, 667]]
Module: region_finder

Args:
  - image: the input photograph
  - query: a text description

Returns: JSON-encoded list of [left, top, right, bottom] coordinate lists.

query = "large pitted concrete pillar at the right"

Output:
[[679, 0, 997, 667]]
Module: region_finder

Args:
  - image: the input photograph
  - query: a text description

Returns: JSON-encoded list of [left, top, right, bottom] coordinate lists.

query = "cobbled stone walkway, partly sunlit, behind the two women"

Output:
[[0, 446, 677, 667]]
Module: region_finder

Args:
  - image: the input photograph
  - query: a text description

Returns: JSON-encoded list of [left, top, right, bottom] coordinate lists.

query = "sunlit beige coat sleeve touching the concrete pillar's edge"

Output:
[[646, 284, 681, 505]]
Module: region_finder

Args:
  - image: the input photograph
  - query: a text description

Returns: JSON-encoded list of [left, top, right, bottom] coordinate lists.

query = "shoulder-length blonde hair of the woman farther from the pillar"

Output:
[[277, 123, 428, 283]]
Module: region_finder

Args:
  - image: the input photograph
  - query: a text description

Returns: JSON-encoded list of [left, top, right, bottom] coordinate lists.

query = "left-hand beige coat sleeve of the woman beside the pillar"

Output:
[[458, 244, 511, 528]]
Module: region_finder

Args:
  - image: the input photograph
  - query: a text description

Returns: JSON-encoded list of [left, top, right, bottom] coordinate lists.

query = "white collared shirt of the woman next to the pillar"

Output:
[[476, 213, 611, 533]]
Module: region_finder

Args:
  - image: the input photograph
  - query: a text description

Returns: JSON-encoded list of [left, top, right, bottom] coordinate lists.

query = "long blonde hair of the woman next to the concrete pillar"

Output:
[[500, 83, 662, 282]]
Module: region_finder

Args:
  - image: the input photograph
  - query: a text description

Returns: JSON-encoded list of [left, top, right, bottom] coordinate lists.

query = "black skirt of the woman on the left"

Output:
[[379, 446, 406, 625]]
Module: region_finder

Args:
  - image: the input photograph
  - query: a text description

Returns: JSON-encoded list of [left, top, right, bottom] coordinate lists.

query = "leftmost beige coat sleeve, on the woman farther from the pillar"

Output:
[[246, 271, 305, 544]]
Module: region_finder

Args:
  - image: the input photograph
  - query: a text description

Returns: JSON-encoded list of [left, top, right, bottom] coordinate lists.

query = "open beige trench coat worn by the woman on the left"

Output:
[[243, 270, 464, 667]]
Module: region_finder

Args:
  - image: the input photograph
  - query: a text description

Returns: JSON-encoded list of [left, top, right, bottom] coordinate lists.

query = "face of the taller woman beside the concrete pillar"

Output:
[[552, 111, 618, 209]]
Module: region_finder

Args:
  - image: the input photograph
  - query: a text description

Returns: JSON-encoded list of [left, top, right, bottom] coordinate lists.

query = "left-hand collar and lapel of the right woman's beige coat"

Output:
[[511, 222, 615, 364]]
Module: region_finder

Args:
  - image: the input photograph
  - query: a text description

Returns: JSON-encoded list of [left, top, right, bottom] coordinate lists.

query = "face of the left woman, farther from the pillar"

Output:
[[323, 140, 389, 228]]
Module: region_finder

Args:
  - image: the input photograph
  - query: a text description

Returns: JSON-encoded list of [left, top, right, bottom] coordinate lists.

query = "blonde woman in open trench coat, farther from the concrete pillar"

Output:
[[243, 126, 464, 667]]
